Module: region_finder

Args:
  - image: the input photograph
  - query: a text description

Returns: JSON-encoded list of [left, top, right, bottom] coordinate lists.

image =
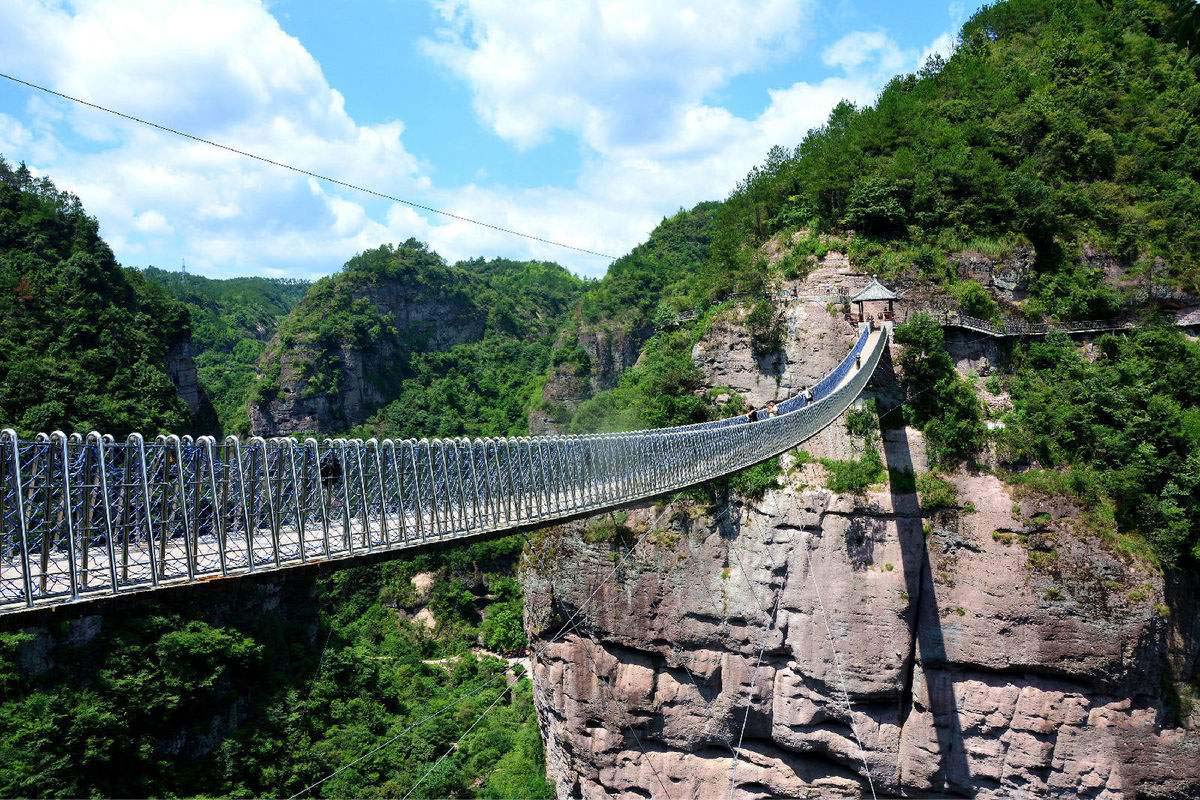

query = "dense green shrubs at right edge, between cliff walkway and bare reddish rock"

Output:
[[1000, 329, 1200, 565]]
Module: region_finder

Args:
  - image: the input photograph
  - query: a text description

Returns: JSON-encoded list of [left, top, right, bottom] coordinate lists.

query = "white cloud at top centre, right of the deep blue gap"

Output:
[[425, 0, 812, 152]]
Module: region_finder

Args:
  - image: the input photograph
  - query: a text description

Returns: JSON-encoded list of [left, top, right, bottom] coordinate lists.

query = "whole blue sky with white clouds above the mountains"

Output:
[[0, 0, 978, 277]]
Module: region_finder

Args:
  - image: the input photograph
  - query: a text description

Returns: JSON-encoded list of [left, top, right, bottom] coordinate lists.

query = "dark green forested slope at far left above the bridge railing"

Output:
[[0, 158, 199, 435]]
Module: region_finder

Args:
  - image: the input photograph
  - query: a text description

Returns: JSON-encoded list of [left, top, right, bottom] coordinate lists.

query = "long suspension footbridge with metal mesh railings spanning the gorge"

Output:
[[0, 327, 890, 614]]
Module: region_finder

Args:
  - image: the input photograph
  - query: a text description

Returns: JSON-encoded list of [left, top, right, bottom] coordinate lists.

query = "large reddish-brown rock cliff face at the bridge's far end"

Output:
[[526, 273, 1200, 799]]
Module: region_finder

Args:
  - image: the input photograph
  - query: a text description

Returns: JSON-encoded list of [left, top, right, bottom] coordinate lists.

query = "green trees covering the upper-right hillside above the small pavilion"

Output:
[[713, 0, 1200, 318]]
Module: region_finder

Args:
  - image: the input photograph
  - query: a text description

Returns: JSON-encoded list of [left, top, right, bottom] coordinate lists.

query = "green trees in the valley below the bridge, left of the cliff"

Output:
[[0, 537, 552, 798]]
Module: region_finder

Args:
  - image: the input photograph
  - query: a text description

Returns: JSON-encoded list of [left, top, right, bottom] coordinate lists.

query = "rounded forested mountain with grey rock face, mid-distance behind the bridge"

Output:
[[251, 240, 586, 435]]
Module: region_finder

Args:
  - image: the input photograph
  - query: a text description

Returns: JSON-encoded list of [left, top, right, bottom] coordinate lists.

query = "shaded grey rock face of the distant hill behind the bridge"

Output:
[[250, 281, 486, 435]]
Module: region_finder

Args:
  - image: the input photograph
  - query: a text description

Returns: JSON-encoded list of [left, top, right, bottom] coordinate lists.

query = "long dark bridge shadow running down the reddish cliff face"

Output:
[[876, 353, 974, 796]]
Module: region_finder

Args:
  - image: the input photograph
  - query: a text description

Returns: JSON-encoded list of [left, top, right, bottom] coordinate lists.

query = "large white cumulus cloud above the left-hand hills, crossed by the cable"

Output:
[[0, 0, 430, 273]]
